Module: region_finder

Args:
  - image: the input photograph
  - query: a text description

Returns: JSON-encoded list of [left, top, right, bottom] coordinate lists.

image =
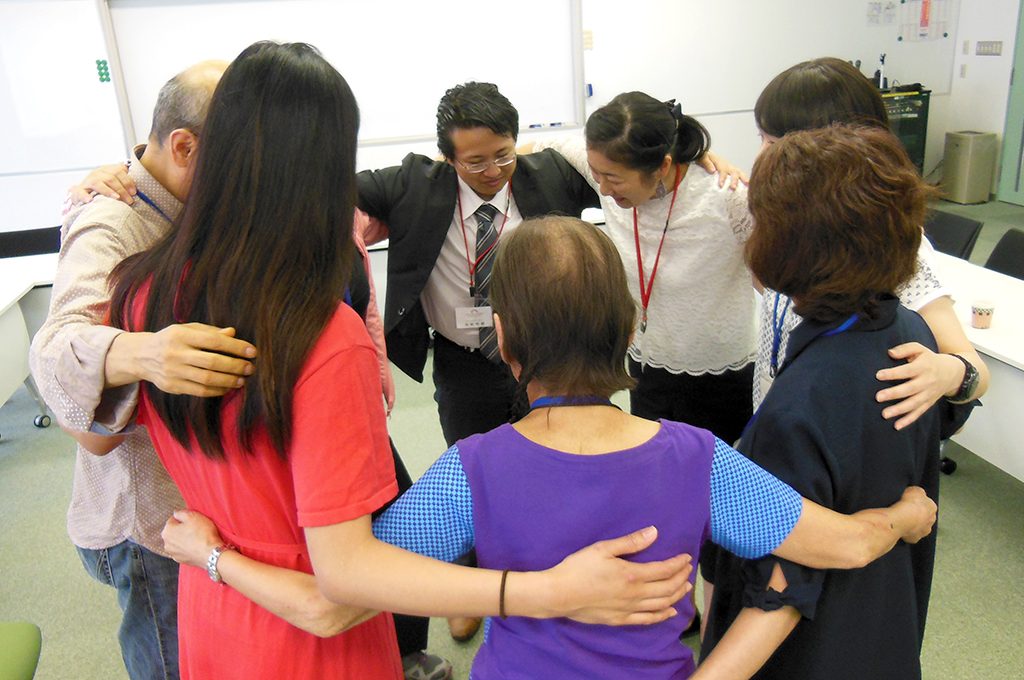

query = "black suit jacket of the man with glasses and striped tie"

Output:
[[356, 150, 600, 382]]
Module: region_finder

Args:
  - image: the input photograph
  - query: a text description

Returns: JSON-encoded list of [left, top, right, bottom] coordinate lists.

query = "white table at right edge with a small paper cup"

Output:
[[935, 253, 1024, 481]]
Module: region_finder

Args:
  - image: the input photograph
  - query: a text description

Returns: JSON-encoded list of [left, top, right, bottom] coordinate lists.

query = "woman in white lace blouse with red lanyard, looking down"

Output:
[[534, 92, 755, 441]]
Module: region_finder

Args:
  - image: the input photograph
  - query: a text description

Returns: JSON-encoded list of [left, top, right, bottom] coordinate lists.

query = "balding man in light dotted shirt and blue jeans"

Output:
[[30, 61, 247, 680]]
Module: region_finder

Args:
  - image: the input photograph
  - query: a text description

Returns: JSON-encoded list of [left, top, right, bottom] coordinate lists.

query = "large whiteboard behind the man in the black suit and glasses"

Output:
[[106, 0, 583, 144]]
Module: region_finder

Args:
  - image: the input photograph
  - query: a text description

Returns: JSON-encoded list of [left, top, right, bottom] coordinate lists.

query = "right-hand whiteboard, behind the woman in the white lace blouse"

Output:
[[583, 0, 959, 115]]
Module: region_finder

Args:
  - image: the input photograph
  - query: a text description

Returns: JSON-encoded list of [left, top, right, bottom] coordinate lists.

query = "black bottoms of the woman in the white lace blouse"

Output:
[[630, 358, 754, 444]]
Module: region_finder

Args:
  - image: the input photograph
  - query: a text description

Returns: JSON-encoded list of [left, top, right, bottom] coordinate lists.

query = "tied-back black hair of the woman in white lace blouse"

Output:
[[585, 92, 711, 174]]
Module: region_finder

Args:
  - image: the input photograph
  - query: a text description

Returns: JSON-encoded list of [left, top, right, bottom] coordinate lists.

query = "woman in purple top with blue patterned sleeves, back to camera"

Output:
[[164, 217, 935, 680]]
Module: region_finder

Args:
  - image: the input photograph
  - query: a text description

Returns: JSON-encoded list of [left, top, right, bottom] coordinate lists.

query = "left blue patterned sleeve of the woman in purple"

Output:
[[374, 444, 474, 562]]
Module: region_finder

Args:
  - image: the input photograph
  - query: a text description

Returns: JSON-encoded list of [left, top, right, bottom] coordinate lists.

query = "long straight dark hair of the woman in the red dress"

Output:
[[112, 42, 358, 458]]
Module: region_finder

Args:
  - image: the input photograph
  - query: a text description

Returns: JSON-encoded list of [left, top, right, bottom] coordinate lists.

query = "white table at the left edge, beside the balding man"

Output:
[[0, 253, 57, 427]]
